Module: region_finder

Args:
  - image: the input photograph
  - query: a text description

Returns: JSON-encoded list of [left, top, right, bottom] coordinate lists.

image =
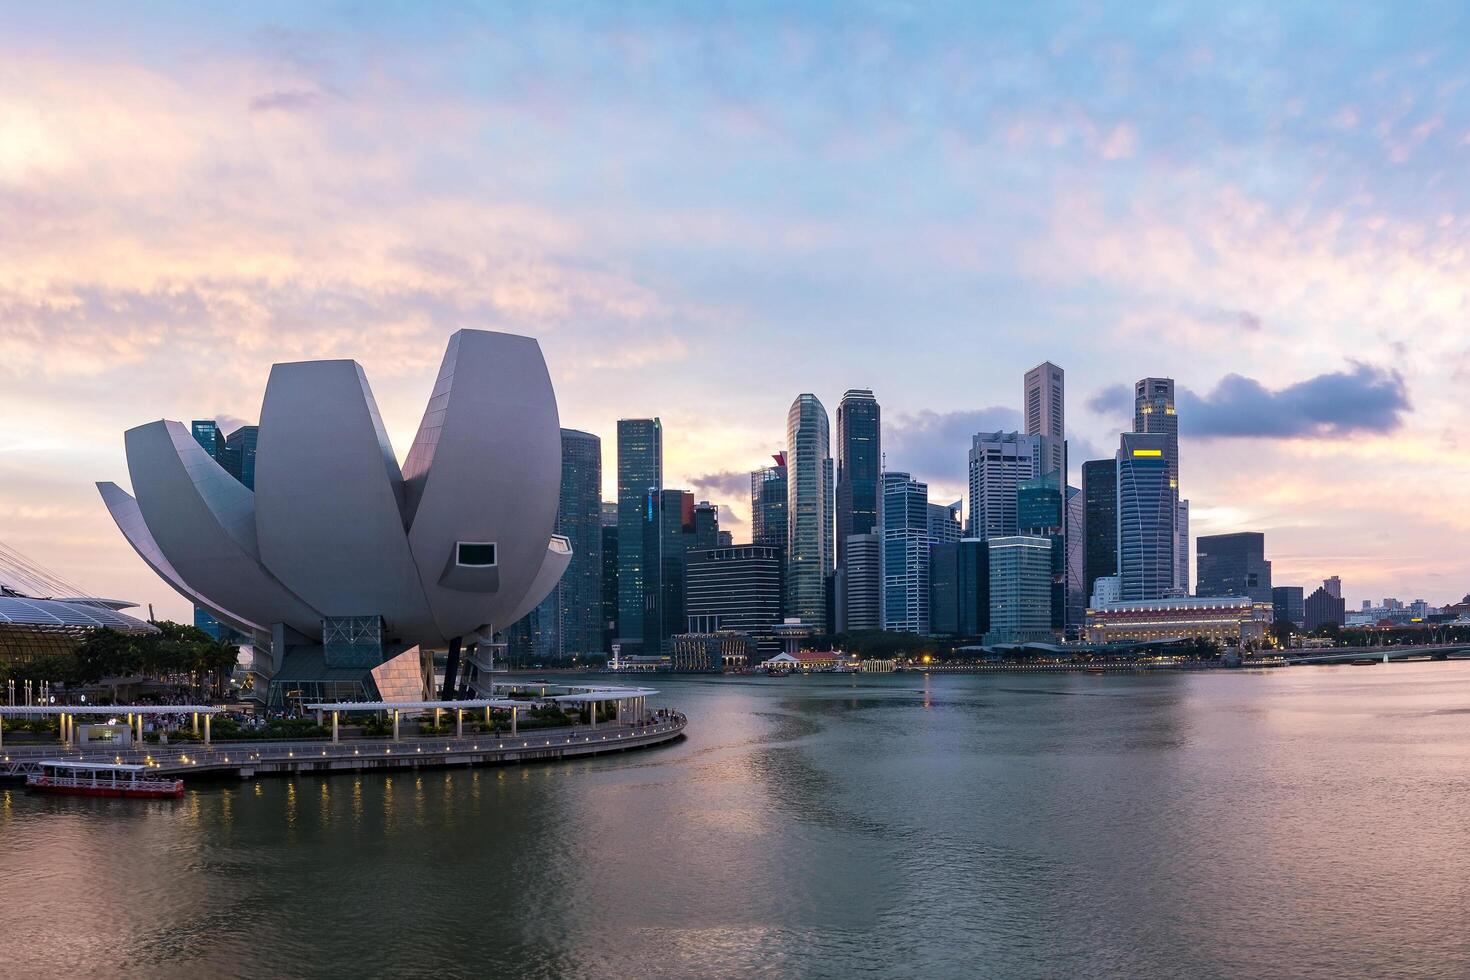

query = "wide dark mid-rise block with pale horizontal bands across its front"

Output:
[[685, 545, 785, 635]]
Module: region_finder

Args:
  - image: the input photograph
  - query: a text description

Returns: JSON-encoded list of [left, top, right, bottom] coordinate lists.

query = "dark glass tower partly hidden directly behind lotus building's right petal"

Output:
[[551, 429, 604, 658]]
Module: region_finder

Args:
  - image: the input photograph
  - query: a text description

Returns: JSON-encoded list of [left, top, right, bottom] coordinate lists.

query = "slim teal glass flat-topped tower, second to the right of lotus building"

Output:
[[617, 419, 663, 652]]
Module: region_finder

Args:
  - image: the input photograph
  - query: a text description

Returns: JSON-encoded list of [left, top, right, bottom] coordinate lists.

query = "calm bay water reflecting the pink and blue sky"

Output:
[[0, 663, 1470, 977]]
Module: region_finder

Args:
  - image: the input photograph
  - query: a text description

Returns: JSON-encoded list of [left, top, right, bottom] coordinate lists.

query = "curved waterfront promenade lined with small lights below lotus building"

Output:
[[0, 711, 688, 779]]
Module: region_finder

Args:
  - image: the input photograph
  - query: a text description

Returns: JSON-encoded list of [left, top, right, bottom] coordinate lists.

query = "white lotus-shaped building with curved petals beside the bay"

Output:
[[97, 331, 572, 705]]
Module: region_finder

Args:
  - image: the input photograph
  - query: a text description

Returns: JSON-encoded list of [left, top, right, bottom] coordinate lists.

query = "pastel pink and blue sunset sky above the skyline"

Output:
[[0, 0, 1470, 619]]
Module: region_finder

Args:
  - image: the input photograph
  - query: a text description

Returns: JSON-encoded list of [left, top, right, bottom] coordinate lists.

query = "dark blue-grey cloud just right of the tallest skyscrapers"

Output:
[[1179, 361, 1410, 439]]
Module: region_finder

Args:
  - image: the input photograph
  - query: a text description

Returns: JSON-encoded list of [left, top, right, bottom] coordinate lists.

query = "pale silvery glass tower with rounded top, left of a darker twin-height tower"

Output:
[[786, 394, 832, 633]]
